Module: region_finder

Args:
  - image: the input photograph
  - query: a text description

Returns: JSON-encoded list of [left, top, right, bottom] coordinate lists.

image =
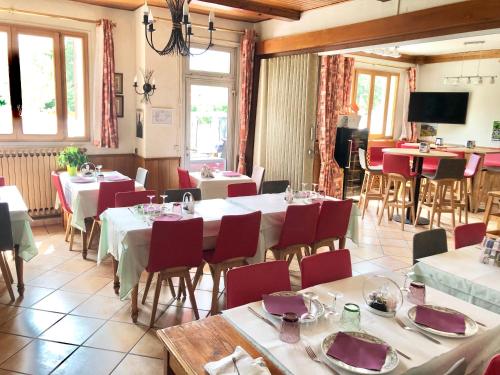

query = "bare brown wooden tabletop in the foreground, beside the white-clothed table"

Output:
[[156, 315, 282, 375]]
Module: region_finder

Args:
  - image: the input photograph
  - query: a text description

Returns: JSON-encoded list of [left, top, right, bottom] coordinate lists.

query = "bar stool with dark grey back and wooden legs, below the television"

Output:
[[417, 159, 466, 229]]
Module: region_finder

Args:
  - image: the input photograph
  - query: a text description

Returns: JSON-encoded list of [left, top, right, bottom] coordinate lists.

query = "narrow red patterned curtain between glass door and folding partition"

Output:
[[238, 29, 255, 173]]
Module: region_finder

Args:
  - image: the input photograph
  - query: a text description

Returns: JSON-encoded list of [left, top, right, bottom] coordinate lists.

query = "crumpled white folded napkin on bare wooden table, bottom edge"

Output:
[[205, 346, 271, 375]]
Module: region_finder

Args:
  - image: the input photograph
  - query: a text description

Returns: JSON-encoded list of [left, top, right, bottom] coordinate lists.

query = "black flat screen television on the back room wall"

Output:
[[408, 92, 469, 124]]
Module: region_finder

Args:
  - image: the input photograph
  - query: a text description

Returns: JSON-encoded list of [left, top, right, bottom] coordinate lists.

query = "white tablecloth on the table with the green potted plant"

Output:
[[60, 172, 144, 231]]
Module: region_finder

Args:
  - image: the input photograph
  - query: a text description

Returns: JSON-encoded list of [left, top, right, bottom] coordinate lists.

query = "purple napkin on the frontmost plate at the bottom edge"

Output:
[[327, 332, 389, 371]]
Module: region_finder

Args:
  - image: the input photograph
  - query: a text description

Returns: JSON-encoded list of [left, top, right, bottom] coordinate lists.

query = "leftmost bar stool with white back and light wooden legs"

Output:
[[358, 148, 385, 219]]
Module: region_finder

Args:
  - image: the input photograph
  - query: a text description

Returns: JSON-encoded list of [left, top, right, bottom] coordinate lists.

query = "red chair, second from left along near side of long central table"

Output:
[[194, 211, 262, 315]]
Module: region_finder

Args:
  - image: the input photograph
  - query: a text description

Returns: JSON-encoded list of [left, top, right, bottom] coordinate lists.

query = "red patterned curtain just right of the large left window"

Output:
[[94, 20, 118, 148]]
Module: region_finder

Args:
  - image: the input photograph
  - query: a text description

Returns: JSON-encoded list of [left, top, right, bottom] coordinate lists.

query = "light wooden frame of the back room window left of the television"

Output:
[[352, 68, 401, 139]]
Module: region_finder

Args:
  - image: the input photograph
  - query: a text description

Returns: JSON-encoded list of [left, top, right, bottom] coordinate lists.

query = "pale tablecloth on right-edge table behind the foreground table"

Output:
[[414, 246, 500, 316]]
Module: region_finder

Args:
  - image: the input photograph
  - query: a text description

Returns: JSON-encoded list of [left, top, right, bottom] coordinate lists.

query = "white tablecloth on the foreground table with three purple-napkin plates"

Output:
[[223, 273, 500, 375]]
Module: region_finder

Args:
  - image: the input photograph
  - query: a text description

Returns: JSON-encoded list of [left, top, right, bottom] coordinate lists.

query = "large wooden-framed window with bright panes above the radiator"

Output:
[[0, 25, 88, 141]]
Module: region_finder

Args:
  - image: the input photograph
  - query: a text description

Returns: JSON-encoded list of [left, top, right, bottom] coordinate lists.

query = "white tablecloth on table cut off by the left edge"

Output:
[[0, 186, 38, 261]]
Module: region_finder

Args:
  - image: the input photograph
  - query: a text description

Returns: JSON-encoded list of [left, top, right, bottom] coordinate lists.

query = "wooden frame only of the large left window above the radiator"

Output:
[[0, 23, 90, 142]]
